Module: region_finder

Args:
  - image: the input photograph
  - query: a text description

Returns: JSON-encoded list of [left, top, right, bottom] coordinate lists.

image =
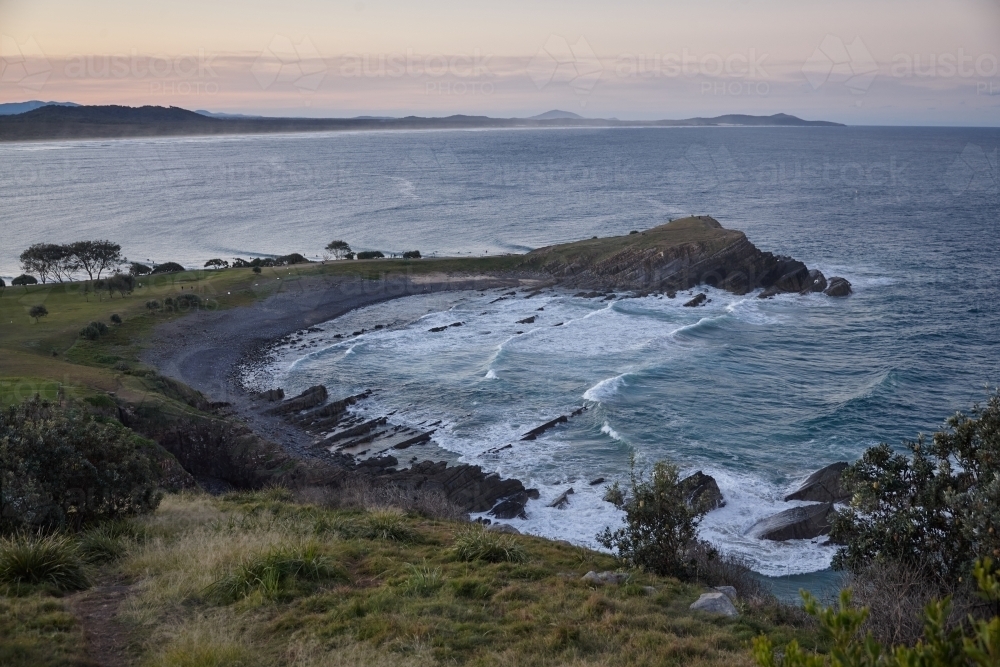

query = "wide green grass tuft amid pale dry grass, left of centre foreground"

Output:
[[205, 544, 346, 604]]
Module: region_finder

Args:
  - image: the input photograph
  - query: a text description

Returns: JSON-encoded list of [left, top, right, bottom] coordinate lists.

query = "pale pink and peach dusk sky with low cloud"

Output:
[[0, 0, 1000, 126]]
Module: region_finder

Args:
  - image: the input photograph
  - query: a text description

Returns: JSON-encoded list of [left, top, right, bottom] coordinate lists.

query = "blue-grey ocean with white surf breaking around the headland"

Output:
[[0, 127, 1000, 577]]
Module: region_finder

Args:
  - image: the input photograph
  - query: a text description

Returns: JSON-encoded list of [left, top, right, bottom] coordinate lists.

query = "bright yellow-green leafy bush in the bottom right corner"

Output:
[[753, 558, 1000, 667]]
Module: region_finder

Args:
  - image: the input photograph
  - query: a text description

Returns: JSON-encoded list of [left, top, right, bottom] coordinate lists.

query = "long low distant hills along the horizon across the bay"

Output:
[[0, 105, 839, 141]]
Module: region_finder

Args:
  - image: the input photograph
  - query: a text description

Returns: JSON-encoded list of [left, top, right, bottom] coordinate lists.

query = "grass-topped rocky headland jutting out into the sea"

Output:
[[525, 216, 821, 294]]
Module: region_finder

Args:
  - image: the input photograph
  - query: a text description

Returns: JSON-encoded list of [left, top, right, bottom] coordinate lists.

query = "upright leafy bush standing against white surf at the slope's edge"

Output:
[[597, 460, 704, 579]]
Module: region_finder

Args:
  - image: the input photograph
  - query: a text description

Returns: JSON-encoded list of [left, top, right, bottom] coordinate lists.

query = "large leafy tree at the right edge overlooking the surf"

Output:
[[830, 392, 1000, 581]]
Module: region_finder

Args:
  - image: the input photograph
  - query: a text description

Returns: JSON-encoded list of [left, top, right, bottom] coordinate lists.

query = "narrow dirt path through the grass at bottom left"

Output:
[[72, 582, 130, 667]]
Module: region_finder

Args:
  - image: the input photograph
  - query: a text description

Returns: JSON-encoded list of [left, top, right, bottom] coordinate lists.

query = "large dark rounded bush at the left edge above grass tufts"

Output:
[[0, 397, 160, 531]]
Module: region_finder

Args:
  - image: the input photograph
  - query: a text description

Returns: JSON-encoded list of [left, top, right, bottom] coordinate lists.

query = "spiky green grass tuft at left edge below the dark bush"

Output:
[[0, 533, 90, 591]]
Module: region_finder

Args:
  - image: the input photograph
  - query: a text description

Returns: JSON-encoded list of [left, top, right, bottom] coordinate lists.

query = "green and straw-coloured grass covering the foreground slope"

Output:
[[0, 490, 816, 667]]
